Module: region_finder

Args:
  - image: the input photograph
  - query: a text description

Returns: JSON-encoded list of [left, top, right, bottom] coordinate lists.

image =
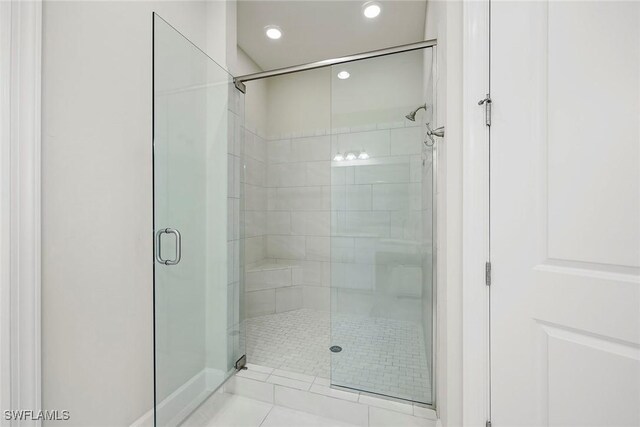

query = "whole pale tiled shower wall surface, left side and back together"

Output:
[[245, 121, 422, 317]]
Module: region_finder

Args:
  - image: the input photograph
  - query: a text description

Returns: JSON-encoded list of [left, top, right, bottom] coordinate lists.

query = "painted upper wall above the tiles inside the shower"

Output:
[[262, 55, 424, 139]]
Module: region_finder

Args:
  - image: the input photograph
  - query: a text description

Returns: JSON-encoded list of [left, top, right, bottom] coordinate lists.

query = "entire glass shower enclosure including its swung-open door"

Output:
[[153, 15, 439, 426]]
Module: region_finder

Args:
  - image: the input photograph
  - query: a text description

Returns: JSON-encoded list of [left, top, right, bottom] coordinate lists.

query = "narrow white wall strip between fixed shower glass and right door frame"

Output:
[[425, 1, 463, 426]]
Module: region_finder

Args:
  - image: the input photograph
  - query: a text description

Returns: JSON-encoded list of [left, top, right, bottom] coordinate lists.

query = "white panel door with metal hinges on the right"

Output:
[[491, 1, 640, 427]]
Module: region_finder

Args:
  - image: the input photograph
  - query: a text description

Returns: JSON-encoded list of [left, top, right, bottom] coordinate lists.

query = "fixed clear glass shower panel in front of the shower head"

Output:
[[331, 49, 435, 404]]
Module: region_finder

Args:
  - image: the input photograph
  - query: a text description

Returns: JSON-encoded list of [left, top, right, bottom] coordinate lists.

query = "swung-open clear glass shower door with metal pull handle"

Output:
[[153, 15, 244, 426]]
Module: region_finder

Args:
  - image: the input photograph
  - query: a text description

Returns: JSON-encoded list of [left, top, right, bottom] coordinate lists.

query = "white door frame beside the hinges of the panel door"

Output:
[[461, 0, 491, 426]]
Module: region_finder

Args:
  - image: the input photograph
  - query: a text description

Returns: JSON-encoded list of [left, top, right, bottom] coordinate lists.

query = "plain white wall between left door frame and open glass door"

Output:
[[42, 1, 227, 426]]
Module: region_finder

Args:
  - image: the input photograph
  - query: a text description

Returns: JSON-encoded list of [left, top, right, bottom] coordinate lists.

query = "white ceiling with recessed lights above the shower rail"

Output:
[[237, 0, 426, 70]]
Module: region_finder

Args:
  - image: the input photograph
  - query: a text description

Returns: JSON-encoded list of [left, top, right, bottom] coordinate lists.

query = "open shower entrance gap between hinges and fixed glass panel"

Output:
[[239, 68, 331, 378]]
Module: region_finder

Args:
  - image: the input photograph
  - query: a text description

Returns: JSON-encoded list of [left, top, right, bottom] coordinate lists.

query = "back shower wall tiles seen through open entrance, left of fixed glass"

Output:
[[267, 135, 331, 310]]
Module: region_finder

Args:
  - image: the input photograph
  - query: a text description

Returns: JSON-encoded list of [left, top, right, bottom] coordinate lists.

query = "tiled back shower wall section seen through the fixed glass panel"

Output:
[[331, 121, 423, 320]]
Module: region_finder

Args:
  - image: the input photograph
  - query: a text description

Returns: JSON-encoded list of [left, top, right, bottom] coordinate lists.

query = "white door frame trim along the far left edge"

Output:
[[0, 0, 42, 425]]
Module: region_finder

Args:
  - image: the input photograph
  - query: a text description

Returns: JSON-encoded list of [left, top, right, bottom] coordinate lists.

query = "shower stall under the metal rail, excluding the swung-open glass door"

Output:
[[236, 43, 442, 405]]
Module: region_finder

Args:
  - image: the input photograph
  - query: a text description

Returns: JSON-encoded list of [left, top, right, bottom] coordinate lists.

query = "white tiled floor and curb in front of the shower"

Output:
[[180, 363, 440, 427]]
